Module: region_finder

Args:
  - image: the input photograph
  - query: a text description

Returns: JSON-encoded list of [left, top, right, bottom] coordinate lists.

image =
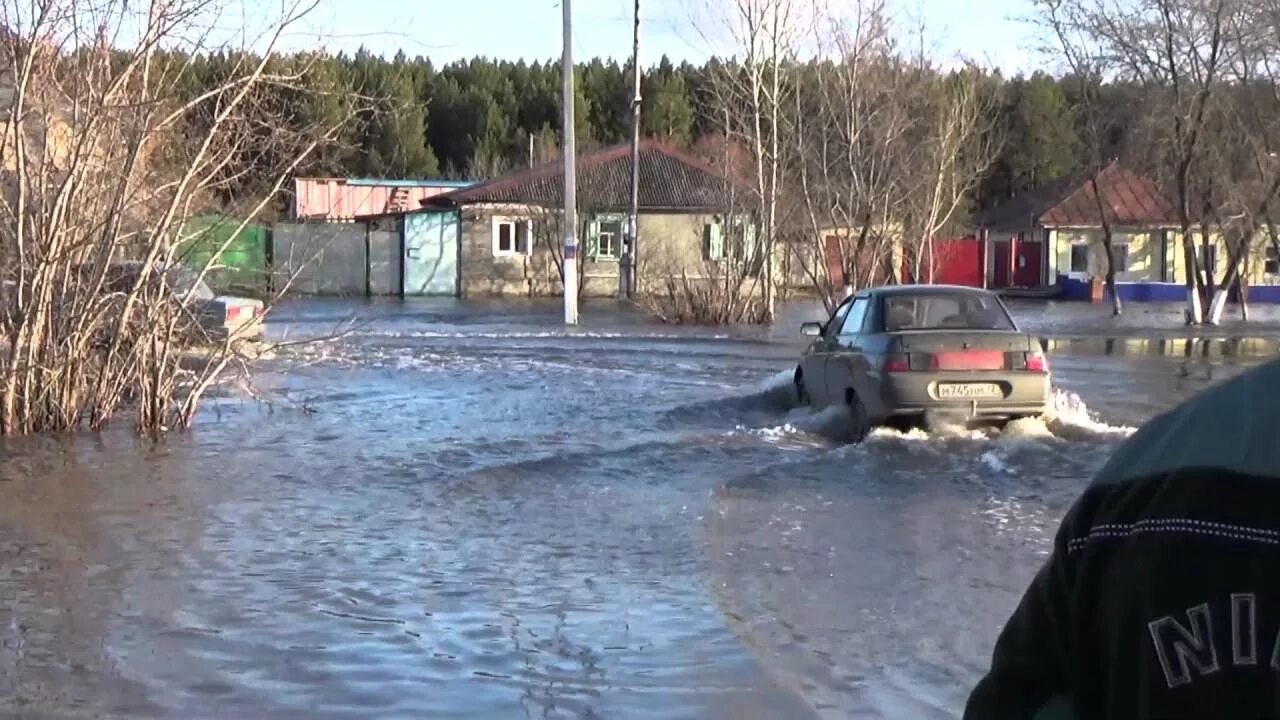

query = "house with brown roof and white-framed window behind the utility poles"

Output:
[[404, 140, 755, 297]]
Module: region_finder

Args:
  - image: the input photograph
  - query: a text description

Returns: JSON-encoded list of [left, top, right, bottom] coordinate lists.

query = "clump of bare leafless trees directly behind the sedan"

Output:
[[783, 0, 997, 310]]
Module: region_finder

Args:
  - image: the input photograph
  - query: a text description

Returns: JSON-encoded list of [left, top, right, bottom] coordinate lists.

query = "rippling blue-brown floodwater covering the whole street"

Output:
[[0, 294, 1280, 720]]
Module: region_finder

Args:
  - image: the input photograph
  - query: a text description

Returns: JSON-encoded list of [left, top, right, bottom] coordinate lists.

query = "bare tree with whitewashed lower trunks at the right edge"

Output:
[[1038, 0, 1280, 324]]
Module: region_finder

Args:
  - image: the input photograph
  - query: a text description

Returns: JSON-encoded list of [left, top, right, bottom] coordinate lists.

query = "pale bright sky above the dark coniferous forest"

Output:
[[267, 0, 1043, 73]]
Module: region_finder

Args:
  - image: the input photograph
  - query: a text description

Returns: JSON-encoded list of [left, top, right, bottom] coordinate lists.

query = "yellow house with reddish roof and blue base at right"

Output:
[[975, 161, 1182, 300]]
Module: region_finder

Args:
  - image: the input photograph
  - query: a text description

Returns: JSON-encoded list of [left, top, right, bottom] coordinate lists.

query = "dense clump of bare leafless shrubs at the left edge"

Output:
[[0, 0, 350, 434]]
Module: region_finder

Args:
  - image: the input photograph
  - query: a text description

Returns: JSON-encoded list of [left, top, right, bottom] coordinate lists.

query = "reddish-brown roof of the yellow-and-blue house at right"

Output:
[[978, 163, 1178, 229]]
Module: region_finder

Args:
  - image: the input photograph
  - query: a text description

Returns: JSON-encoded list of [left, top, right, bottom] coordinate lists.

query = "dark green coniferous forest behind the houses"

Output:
[[222, 51, 1134, 208]]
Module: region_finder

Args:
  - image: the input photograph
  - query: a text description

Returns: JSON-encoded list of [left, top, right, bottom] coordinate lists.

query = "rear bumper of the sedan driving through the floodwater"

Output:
[[881, 373, 1050, 418]]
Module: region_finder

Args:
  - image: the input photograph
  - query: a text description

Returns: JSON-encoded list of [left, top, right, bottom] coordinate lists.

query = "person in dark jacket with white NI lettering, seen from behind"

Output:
[[964, 361, 1280, 720]]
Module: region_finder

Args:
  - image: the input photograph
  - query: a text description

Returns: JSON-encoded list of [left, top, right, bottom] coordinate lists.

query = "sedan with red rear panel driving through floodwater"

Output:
[[795, 286, 1051, 442]]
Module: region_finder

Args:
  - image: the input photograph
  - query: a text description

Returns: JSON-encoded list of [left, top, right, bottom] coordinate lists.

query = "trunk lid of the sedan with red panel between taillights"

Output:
[[890, 331, 1039, 370]]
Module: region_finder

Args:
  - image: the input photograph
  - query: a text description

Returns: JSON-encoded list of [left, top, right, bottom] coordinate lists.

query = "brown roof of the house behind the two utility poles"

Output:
[[424, 140, 728, 210]]
